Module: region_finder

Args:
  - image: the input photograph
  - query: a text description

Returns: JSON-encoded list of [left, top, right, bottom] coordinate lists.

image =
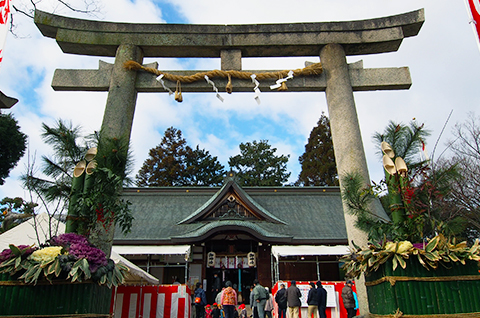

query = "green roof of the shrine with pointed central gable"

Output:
[[115, 181, 347, 244]]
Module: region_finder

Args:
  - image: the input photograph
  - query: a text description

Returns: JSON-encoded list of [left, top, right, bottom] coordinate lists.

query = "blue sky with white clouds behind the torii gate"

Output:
[[0, 0, 480, 204]]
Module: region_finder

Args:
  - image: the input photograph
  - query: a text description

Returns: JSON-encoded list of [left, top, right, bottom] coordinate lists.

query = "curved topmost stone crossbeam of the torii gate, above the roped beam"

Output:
[[35, 9, 425, 58]]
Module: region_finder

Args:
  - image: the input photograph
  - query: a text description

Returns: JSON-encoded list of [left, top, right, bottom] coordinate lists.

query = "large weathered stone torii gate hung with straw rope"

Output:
[[35, 9, 425, 313]]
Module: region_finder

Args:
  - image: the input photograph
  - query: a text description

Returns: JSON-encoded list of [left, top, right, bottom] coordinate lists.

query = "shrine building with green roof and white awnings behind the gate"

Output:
[[113, 174, 386, 299]]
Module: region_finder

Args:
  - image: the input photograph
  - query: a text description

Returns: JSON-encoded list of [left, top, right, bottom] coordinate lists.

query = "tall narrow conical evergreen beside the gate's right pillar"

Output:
[[295, 112, 338, 186]]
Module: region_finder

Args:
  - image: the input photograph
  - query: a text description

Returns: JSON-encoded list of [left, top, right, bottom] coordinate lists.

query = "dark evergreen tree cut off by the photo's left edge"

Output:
[[0, 114, 27, 185]]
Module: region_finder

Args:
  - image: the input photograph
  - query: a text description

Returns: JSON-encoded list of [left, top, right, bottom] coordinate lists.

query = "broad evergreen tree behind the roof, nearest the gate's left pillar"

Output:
[[136, 127, 225, 187]]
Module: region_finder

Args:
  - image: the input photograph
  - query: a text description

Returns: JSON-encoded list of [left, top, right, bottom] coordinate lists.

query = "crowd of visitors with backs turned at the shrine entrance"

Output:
[[193, 276, 334, 318]]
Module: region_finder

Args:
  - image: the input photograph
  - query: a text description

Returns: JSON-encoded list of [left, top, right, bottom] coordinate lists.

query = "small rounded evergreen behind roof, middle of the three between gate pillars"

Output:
[[228, 140, 290, 186]]
